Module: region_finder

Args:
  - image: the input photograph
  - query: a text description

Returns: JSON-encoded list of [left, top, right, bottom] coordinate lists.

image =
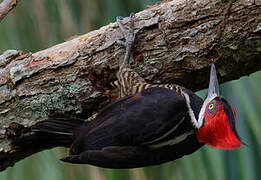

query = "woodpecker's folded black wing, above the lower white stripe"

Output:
[[79, 87, 197, 149]]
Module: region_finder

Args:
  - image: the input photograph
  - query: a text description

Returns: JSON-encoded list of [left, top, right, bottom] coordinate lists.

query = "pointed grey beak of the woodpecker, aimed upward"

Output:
[[206, 64, 220, 99]]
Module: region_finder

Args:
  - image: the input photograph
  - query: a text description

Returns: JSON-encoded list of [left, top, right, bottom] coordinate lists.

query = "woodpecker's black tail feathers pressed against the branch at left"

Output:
[[14, 116, 85, 149]]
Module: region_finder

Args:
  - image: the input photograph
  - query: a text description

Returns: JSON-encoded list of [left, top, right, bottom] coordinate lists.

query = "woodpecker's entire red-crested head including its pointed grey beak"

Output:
[[196, 64, 243, 149]]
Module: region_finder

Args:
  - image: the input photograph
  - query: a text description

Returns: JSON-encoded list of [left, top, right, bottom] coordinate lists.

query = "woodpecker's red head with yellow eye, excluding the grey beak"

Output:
[[197, 97, 243, 149]]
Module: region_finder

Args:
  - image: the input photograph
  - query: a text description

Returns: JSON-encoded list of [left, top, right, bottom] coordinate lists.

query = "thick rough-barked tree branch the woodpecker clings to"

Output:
[[0, 0, 261, 170]]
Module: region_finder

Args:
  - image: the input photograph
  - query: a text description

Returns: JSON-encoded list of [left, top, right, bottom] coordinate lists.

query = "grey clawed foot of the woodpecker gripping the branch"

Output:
[[116, 13, 135, 69]]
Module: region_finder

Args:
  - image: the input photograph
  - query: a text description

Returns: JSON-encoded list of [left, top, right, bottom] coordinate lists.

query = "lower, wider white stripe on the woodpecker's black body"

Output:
[[149, 130, 195, 149]]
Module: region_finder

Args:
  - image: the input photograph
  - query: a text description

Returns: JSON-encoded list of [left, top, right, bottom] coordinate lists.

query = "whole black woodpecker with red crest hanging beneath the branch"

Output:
[[13, 14, 243, 169]]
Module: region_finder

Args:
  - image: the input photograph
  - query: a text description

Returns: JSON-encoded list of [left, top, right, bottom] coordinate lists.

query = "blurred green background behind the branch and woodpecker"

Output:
[[0, 0, 261, 180]]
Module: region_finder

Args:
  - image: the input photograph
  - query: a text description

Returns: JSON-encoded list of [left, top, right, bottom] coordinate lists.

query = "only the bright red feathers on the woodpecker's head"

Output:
[[197, 101, 243, 150]]
